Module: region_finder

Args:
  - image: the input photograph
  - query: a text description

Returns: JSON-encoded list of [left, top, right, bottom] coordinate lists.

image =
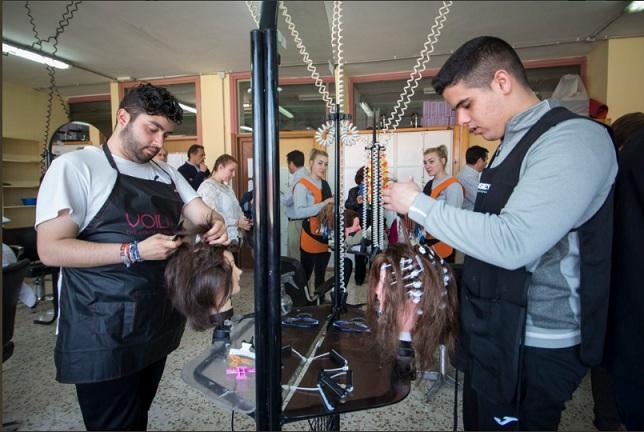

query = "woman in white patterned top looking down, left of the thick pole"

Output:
[[197, 154, 252, 250]]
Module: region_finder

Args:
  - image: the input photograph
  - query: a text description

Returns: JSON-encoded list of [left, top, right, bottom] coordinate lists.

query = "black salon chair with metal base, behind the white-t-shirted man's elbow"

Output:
[[2, 226, 60, 324]]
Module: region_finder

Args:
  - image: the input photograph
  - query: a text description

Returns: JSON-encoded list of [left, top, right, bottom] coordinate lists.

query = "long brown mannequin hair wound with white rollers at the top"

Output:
[[367, 243, 458, 370]]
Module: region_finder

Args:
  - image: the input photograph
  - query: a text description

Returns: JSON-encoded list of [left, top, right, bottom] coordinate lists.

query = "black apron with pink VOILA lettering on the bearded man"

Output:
[[55, 145, 185, 384]]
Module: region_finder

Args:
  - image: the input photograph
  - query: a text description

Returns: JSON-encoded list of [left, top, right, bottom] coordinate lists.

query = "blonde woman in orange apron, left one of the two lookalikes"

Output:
[[293, 149, 333, 291]]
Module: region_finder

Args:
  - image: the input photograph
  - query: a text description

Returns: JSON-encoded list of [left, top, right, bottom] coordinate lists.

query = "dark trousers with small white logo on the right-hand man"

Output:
[[463, 345, 587, 431]]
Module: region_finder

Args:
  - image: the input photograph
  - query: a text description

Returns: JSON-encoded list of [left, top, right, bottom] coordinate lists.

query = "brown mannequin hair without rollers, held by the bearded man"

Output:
[[165, 226, 233, 331]]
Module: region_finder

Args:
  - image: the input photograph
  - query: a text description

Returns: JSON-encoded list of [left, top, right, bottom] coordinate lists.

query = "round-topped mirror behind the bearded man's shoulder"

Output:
[[47, 121, 107, 166]]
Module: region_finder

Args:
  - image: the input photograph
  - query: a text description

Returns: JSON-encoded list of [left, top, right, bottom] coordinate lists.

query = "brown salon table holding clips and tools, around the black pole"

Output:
[[182, 305, 411, 429]]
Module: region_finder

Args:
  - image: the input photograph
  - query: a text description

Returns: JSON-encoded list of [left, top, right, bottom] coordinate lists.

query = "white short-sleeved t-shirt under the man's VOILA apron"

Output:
[[36, 146, 198, 232]]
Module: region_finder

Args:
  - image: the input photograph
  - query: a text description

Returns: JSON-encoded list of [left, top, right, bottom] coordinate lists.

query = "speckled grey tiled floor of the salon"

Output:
[[2, 272, 594, 431]]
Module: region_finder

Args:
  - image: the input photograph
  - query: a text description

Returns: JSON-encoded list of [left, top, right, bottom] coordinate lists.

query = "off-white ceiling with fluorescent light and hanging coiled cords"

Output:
[[2, 1, 644, 96]]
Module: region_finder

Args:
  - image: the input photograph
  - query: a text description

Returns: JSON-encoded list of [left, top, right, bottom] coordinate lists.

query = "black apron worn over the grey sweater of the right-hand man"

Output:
[[459, 107, 613, 403]]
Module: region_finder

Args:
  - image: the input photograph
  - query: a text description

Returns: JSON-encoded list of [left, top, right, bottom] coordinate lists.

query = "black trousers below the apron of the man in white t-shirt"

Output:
[[76, 357, 167, 431]]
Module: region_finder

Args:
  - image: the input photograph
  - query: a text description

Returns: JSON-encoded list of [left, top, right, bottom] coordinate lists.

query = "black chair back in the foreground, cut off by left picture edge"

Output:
[[2, 259, 29, 363]]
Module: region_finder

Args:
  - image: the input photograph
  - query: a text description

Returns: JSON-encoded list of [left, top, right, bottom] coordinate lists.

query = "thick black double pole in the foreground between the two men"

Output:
[[251, 1, 282, 431]]
